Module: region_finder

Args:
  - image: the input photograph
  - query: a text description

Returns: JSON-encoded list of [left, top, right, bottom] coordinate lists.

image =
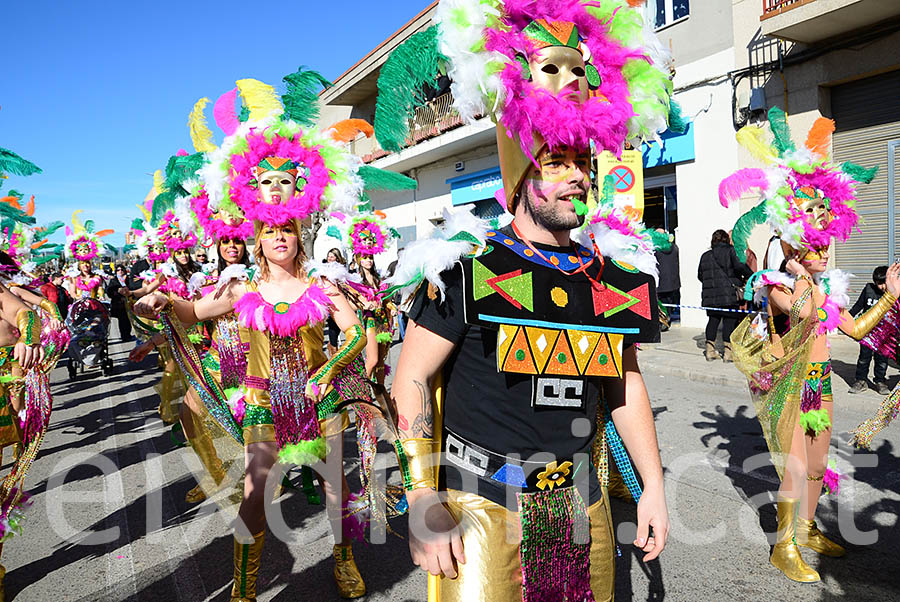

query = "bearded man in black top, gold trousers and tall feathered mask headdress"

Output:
[[376, 0, 671, 602]]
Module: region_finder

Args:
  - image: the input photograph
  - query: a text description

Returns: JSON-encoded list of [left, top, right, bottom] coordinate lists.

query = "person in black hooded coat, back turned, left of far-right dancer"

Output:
[[697, 230, 753, 362]]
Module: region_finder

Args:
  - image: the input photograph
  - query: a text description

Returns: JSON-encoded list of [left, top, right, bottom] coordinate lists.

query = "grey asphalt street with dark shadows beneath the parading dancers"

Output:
[[3, 328, 900, 602]]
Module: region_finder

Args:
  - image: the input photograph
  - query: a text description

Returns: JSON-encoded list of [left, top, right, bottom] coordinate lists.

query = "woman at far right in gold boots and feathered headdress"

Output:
[[719, 107, 900, 582]]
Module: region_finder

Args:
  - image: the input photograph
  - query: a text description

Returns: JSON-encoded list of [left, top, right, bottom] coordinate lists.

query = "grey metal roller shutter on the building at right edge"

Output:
[[831, 71, 900, 278]]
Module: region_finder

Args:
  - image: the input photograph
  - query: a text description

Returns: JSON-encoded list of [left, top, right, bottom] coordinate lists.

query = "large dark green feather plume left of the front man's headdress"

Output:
[[375, 26, 446, 152]]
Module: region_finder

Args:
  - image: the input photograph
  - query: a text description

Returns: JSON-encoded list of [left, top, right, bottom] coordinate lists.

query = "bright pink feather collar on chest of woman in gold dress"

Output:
[[234, 284, 332, 337]]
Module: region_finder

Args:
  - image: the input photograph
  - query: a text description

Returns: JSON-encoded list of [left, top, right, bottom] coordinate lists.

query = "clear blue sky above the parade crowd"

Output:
[[0, 0, 429, 246]]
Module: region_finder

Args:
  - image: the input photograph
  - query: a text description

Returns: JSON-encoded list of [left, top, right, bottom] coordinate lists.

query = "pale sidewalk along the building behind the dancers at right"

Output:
[[638, 324, 900, 399]]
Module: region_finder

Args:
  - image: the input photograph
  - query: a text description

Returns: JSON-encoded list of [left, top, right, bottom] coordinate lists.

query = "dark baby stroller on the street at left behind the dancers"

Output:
[[66, 299, 112, 380]]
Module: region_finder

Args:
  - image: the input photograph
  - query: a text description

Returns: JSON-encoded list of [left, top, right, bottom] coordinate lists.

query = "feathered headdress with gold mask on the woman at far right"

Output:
[[719, 107, 877, 250]]
